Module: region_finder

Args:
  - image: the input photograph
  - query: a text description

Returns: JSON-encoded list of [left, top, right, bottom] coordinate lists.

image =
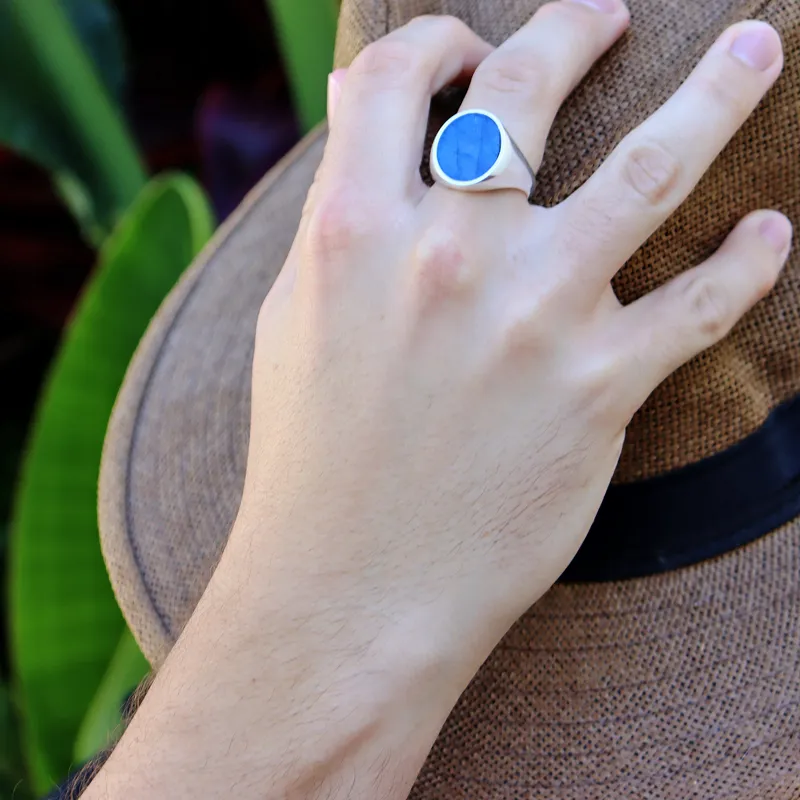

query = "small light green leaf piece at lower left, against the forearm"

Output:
[[75, 628, 150, 764]]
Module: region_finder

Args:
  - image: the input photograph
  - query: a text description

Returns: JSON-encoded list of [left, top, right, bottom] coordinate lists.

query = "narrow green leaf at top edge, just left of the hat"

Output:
[[267, 0, 339, 131]]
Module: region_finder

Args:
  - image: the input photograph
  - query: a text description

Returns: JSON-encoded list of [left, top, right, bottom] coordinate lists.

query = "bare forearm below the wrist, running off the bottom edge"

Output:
[[83, 536, 476, 800]]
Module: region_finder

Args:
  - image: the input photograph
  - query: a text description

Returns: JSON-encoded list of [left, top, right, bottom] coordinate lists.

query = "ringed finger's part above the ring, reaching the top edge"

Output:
[[462, 0, 630, 170]]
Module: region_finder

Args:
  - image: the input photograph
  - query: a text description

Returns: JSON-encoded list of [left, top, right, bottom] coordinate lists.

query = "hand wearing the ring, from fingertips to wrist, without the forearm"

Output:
[[231, 2, 790, 669]]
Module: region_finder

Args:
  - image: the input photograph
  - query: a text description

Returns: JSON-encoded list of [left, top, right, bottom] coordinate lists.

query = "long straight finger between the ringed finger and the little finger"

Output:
[[554, 21, 783, 287]]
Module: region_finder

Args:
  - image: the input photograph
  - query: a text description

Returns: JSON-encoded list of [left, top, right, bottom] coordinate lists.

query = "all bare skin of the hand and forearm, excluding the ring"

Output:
[[84, 0, 791, 800]]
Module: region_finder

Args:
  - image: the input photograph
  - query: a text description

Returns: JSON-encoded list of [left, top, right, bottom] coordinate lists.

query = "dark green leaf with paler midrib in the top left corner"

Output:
[[0, 0, 145, 244]]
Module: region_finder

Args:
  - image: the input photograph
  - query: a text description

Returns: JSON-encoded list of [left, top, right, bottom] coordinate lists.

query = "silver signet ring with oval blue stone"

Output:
[[431, 108, 536, 203]]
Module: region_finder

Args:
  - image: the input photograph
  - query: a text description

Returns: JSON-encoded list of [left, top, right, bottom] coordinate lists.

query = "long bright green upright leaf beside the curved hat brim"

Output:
[[10, 175, 213, 793]]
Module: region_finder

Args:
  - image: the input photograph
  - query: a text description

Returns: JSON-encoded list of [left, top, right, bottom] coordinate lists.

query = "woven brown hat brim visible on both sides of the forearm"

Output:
[[100, 129, 800, 800]]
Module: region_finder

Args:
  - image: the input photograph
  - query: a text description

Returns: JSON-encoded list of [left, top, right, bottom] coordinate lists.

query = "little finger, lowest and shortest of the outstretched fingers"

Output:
[[613, 211, 792, 407]]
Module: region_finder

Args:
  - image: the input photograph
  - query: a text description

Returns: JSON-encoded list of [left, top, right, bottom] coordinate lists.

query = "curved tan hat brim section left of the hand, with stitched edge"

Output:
[[98, 126, 327, 666]]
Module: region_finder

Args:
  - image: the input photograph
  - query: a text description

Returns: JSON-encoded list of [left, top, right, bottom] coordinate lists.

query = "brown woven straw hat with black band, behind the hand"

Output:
[[100, 0, 800, 800]]
